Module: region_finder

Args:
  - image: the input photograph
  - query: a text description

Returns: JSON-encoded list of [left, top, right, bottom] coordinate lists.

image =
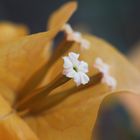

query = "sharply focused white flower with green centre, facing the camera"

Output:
[[63, 52, 89, 86]]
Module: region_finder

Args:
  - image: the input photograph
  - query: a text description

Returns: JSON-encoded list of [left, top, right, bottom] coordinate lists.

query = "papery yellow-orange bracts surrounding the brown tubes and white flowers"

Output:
[[0, 2, 140, 140]]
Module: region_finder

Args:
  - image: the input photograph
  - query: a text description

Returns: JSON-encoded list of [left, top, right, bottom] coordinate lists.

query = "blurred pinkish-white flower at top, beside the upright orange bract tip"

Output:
[[62, 24, 90, 49]]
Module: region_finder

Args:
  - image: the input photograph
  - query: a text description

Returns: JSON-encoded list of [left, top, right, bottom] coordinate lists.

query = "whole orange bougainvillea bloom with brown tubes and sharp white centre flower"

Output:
[[0, 2, 140, 140]]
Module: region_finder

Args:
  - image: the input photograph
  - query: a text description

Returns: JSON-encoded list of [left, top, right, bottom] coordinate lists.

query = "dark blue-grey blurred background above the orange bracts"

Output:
[[0, 0, 140, 53]]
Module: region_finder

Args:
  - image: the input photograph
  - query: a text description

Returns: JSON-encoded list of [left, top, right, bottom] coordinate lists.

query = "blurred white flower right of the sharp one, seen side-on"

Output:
[[94, 58, 117, 89]]
